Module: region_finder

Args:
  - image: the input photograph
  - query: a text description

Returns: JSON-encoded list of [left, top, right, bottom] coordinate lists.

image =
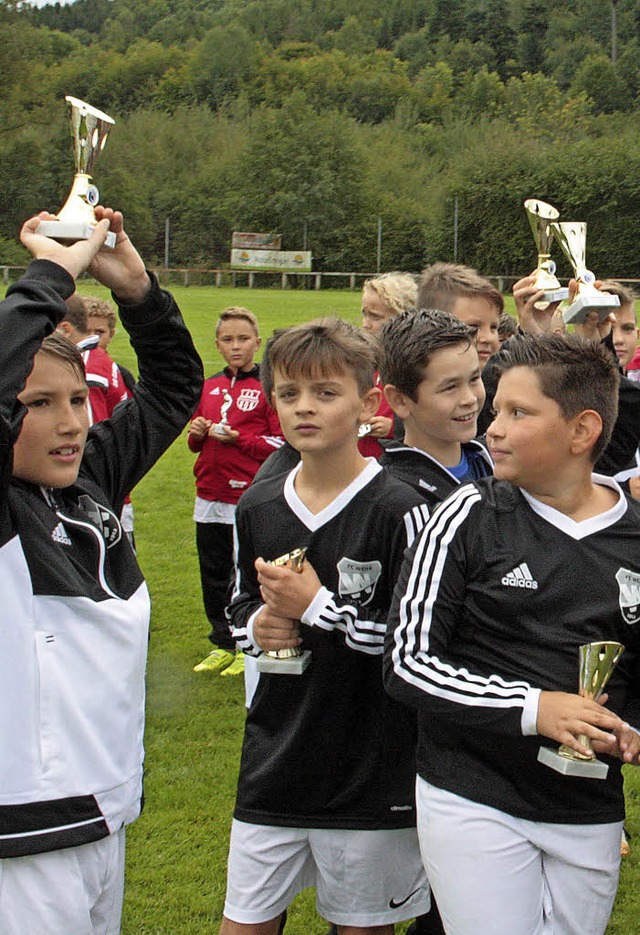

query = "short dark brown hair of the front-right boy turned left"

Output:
[[495, 333, 620, 462]]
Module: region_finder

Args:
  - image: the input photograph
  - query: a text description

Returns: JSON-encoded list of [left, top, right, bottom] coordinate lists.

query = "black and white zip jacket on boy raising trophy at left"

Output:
[[0, 260, 202, 860]]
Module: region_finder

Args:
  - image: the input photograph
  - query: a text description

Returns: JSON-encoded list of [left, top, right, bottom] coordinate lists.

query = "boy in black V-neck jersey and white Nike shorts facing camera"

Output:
[[220, 319, 429, 935]]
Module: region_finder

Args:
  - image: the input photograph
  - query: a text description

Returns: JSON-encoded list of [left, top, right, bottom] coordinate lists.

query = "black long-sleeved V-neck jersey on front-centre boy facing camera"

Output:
[[229, 461, 427, 829]]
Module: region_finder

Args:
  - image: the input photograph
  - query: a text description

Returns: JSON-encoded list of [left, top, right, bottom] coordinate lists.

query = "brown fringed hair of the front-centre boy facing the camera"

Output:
[[268, 318, 380, 395]]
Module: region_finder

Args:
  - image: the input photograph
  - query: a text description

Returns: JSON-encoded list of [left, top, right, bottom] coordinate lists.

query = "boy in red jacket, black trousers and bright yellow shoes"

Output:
[[187, 306, 282, 675]]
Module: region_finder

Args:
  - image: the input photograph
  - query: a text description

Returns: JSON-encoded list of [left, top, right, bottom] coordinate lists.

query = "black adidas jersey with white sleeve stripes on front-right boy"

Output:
[[385, 475, 640, 824]]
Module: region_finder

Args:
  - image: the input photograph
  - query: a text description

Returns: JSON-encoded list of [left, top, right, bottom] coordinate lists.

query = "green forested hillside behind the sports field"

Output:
[[0, 0, 640, 277]]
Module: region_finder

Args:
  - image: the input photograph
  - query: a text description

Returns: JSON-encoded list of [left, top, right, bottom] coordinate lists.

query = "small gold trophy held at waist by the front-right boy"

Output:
[[538, 640, 624, 779]]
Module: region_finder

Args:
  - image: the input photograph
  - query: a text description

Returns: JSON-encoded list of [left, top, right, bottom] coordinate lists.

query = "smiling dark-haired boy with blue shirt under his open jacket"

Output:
[[380, 310, 492, 508]]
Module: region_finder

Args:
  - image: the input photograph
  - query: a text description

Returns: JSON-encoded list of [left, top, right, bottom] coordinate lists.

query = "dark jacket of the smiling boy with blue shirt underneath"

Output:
[[380, 438, 493, 510]]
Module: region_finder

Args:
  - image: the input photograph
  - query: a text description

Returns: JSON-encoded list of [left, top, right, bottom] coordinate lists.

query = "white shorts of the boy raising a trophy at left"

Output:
[[0, 828, 125, 935]]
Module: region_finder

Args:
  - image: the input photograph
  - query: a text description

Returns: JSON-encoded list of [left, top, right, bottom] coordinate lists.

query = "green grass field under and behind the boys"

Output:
[[8, 283, 640, 935]]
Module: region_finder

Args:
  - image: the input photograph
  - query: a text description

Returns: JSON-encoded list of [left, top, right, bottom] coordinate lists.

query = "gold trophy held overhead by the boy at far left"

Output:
[[38, 96, 116, 249]]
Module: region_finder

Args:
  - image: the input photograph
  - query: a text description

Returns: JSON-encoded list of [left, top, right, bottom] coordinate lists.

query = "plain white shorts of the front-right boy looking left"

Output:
[[416, 777, 622, 935]]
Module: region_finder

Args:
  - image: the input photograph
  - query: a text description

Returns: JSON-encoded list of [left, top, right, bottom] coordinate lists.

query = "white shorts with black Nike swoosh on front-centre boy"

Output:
[[224, 819, 430, 927]]
